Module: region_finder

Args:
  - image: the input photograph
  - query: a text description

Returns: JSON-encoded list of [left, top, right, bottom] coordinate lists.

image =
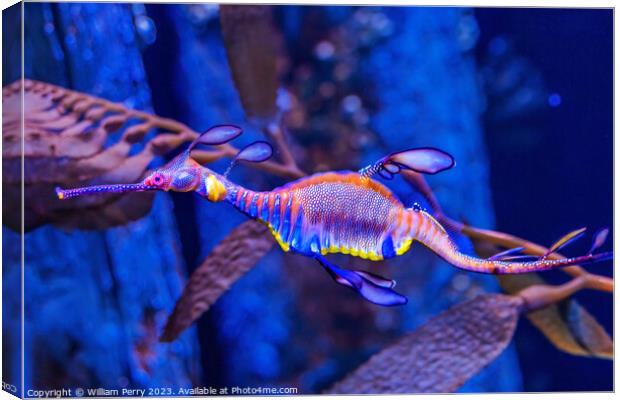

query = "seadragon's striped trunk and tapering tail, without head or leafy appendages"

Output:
[[226, 171, 602, 280]]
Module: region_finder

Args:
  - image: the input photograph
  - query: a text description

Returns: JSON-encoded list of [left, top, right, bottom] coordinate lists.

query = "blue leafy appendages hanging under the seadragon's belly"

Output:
[[315, 255, 407, 306]]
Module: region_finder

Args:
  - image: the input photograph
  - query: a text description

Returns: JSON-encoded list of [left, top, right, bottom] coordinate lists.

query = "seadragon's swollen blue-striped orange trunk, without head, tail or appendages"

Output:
[[228, 172, 431, 261]]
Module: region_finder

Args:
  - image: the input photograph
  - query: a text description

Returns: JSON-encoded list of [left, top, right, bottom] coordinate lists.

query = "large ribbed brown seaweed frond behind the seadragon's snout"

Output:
[[2, 80, 189, 231]]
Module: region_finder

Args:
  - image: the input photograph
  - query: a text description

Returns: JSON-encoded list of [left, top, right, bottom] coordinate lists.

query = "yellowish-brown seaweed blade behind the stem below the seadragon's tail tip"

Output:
[[499, 274, 613, 359]]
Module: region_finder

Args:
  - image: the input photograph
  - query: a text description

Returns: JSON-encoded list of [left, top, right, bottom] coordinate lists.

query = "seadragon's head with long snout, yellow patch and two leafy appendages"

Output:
[[56, 125, 273, 202]]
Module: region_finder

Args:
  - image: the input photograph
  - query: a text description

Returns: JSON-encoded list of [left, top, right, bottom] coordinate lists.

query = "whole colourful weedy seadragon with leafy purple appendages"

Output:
[[56, 125, 613, 306]]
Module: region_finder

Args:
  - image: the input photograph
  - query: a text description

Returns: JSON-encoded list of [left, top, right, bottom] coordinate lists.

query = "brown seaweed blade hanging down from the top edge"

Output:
[[220, 5, 279, 121]]
